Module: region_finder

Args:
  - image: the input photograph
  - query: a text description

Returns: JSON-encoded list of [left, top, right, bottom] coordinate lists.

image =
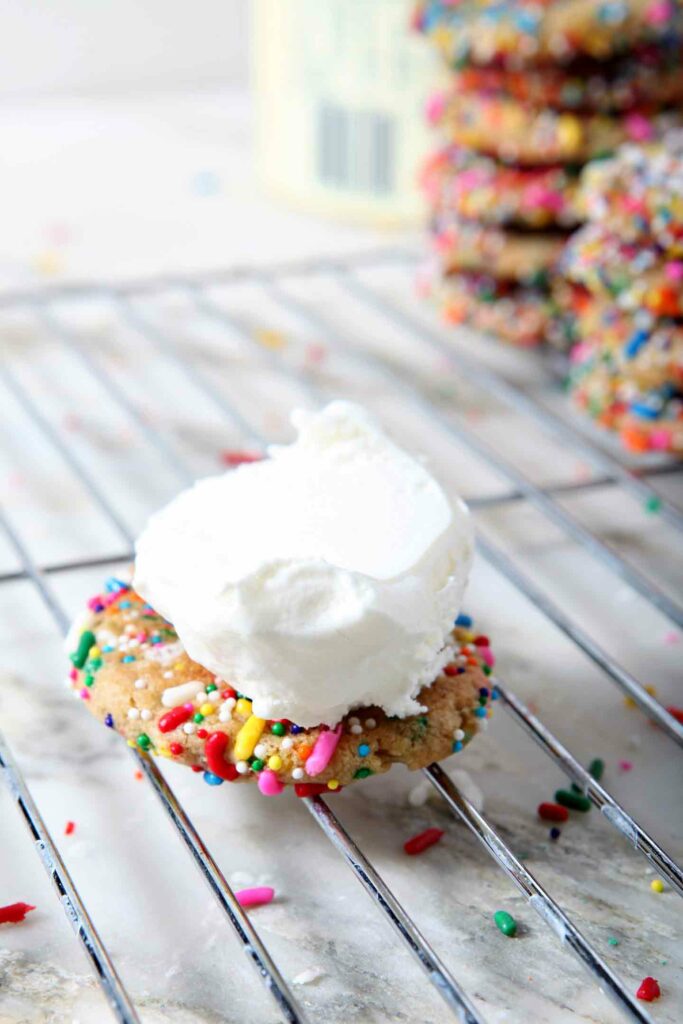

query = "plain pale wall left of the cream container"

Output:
[[0, 0, 249, 96]]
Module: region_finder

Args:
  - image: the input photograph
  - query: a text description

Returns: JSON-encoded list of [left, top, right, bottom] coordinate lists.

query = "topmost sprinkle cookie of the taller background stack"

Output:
[[417, 0, 681, 68]]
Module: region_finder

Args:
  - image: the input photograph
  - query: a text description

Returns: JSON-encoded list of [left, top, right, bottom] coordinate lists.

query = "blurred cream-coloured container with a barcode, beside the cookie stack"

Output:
[[252, 0, 436, 226]]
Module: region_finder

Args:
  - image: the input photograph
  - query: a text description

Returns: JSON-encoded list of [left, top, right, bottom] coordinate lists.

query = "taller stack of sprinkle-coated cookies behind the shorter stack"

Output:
[[417, 0, 683, 345]]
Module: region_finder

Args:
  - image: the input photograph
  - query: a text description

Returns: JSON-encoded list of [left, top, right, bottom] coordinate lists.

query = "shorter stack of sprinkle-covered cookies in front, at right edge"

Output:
[[558, 130, 683, 455]]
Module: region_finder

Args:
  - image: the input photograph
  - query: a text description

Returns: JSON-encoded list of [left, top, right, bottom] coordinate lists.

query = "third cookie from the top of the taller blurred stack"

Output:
[[439, 93, 683, 166]]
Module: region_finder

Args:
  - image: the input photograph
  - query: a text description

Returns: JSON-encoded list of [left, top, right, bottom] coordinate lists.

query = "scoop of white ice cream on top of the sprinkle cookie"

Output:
[[134, 401, 473, 726]]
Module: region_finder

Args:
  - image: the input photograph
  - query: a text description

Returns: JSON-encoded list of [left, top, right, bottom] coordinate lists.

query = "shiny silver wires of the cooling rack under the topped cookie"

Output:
[[0, 253, 683, 1024]]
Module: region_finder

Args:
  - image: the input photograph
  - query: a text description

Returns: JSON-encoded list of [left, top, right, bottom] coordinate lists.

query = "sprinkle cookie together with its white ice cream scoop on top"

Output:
[[70, 401, 494, 796]]
